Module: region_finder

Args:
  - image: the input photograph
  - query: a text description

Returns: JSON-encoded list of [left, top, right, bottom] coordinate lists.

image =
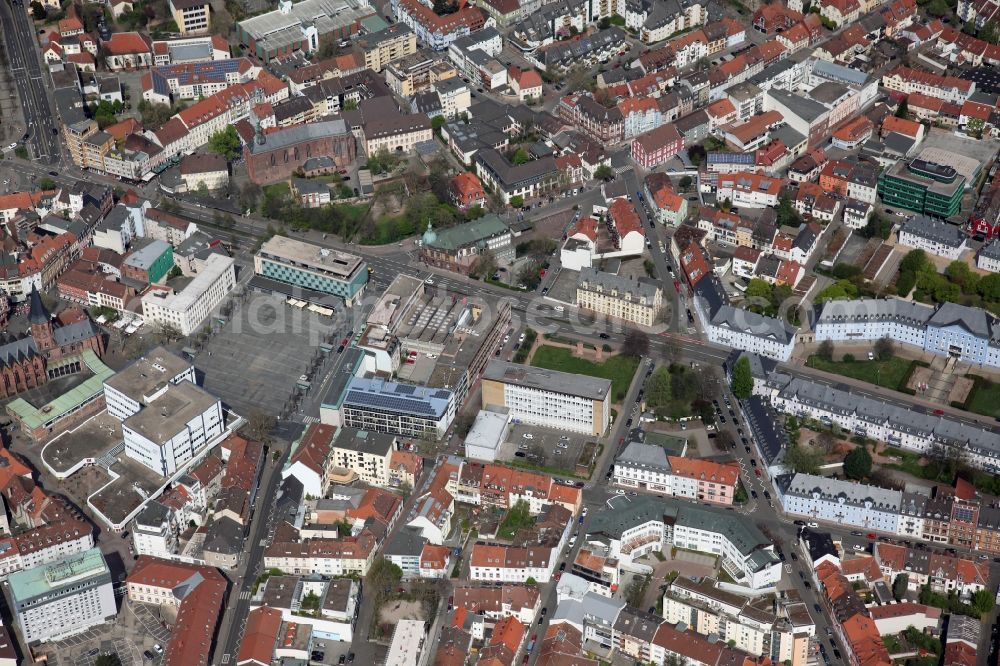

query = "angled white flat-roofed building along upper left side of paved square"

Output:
[[142, 252, 236, 336]]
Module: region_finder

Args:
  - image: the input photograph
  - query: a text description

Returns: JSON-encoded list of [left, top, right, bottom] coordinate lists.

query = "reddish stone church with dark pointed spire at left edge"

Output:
[[0, 289, 104, 399]]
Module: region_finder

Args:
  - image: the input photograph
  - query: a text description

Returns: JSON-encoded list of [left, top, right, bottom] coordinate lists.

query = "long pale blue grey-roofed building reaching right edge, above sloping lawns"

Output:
[[815, 298, 1000, 367]]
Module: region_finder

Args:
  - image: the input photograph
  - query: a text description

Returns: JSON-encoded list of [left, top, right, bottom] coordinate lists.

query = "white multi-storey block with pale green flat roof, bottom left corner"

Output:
[[7, 548, 118, 645]]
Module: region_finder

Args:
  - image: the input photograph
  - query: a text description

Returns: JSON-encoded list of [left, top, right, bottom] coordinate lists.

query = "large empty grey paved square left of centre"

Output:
[[194, 293, 337, 416]]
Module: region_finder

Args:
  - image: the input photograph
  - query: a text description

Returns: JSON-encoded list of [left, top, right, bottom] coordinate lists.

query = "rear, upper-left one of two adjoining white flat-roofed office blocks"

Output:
[[104, 347, 195, 421]]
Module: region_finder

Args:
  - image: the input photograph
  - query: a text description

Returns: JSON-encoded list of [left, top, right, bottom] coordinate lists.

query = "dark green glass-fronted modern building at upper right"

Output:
[[878, 159, 965, 218]]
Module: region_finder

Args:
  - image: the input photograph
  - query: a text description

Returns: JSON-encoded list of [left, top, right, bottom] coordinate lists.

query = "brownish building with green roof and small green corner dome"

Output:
[[420, 213, 514, 275]]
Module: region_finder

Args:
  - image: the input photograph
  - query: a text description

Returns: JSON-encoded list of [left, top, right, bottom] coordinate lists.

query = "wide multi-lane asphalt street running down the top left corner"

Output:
[[0, 0, 59, 164]]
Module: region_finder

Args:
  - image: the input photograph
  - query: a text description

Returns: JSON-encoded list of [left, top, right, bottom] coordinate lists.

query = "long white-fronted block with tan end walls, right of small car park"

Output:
[[482, 360, 611, 436]]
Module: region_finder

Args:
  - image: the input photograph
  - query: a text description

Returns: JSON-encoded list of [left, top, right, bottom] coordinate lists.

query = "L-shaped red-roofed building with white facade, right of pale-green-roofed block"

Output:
[[125, 555, 227, 666]]
